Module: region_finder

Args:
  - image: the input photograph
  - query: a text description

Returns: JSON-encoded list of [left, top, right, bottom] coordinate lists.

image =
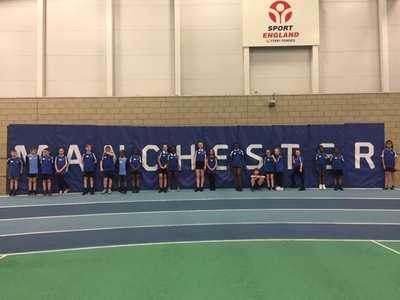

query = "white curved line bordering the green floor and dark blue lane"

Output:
[[7, 239, 400, 256]]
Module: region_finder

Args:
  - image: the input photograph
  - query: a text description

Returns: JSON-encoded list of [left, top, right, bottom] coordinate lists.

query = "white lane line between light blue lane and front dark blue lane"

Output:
[[0, 222, 400, 238]]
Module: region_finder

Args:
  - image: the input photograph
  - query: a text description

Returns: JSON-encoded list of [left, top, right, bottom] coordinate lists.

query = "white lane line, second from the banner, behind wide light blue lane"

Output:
[[0, 208, 400, 223]]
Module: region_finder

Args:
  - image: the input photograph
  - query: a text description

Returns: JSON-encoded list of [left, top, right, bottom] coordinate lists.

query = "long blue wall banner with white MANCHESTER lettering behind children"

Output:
[[8, 123, 384, 192]]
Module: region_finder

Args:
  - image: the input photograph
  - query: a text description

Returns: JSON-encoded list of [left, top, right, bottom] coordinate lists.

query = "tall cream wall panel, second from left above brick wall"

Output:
[[46, 0, 106, 96]]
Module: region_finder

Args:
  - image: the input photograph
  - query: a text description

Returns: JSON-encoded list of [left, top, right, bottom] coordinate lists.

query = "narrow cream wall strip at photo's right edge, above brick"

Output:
[[388, 0, 400, 92]]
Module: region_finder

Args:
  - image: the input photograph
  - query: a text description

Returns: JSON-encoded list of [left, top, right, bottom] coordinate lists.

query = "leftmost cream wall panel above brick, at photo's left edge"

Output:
[[0, 0, 36, 97]]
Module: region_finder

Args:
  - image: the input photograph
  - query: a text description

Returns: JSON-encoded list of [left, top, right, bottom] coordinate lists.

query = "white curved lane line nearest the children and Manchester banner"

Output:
[[0, 196, 400, 208]]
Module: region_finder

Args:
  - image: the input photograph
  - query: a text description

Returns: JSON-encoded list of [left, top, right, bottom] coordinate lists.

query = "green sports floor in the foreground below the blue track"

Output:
[[0, 241, 400, 300]]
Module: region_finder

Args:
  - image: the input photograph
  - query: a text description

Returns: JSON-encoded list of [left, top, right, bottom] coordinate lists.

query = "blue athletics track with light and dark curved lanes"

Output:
[[0, 189, 400, 254]]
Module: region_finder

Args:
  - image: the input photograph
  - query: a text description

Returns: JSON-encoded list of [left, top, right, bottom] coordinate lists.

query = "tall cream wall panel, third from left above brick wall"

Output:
[[114, 0, 175, 96]]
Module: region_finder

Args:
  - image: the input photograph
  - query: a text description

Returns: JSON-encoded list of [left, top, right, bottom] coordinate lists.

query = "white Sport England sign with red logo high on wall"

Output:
[[242, 0, 319, 47]]
